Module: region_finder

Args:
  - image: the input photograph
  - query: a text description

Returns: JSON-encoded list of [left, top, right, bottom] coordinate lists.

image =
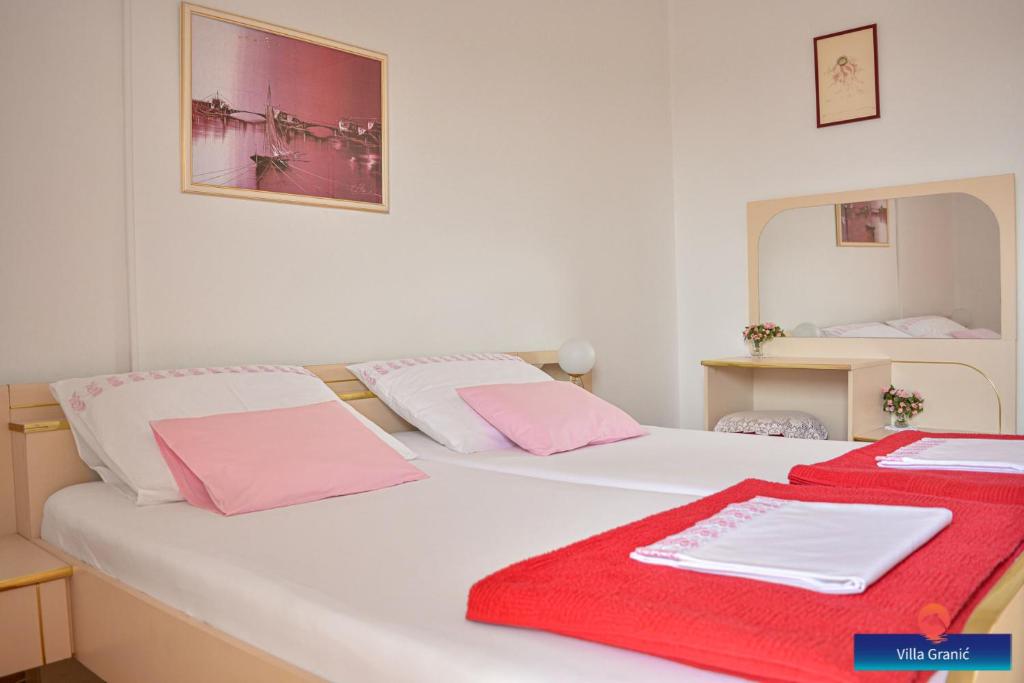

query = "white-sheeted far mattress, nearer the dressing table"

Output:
[[394, 427, 862, 496]]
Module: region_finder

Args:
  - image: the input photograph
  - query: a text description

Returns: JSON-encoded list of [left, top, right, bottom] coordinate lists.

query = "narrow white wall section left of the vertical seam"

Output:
[[0, 0, 128, 384]]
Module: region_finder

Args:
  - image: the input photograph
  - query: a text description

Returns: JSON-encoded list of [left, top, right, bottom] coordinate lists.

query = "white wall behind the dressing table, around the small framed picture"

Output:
[[670, 0, 1024, 426]]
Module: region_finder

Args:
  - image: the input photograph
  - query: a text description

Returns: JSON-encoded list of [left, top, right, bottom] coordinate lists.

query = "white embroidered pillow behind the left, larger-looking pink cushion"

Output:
[[50, 366, 416, 505]]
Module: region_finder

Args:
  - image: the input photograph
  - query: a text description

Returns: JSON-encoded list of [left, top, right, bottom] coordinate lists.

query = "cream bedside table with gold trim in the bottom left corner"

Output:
[[0, 533, 72, 676]]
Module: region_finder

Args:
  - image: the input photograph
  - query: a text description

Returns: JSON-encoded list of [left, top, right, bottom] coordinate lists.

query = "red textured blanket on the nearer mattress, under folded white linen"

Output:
[[466, 479, 1024, 683]]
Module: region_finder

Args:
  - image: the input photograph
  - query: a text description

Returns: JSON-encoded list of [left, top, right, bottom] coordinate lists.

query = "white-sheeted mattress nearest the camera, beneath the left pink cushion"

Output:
[[42, 461, 739, 683]]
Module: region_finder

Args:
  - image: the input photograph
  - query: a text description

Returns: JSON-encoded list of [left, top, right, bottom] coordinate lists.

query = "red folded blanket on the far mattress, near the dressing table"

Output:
[[790, 431, 1024, 505]]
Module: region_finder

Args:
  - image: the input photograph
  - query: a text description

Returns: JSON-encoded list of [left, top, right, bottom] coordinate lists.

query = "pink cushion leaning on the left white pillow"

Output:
[[150, 400, 427, 515]]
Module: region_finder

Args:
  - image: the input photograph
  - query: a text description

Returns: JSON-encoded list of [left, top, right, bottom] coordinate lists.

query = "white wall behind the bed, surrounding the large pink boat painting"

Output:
[[0, 0, 678, 424]]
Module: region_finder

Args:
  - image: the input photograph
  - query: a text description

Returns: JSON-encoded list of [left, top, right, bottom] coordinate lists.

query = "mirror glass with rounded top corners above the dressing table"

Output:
[[758, 193, 1000, 339]]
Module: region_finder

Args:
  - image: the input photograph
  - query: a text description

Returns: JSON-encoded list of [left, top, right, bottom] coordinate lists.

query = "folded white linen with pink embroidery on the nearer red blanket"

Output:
[[630, 496, 952, 595]]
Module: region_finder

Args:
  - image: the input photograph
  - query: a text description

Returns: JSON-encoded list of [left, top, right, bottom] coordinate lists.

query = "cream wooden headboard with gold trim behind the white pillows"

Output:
[[0, 351, 592, 539]]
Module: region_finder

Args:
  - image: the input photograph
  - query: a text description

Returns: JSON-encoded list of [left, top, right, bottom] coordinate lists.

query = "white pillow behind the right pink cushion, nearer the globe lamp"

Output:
[[348, 353, 554, 453]]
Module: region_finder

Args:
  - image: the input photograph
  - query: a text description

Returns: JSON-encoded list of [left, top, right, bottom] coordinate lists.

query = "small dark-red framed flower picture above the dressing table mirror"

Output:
[[814, 24, 882, 128]]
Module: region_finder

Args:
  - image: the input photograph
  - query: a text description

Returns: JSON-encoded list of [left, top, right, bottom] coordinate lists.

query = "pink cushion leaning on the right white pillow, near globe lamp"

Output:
[[457, 382, 647, 456]]
